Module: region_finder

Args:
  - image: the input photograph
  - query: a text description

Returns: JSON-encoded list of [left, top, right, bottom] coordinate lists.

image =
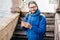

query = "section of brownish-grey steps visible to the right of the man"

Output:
[[44, 13, 55, 40]]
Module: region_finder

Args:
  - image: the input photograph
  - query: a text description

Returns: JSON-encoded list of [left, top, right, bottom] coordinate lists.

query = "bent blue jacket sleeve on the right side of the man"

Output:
[[31, 17, 46, 34]]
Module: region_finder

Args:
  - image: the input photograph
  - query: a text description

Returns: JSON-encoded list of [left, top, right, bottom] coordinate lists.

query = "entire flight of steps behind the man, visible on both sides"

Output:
[[11, 13, 55, 40]]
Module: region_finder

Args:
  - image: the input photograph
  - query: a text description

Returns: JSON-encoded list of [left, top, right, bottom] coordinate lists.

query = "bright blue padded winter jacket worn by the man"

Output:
[[23, 9, 46, 40]]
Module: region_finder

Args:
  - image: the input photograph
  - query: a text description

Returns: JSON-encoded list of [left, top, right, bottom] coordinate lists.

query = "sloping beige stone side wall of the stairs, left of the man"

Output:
[[0, 13, 19, 40]]
